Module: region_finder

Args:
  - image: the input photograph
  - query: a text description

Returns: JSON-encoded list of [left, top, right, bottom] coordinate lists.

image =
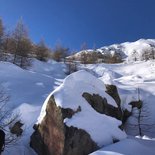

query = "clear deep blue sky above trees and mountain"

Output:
[[0, 0, 155, 49]]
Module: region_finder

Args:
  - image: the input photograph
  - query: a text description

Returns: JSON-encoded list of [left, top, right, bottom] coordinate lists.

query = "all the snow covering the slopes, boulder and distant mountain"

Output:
[[0, 39, 155, 155]]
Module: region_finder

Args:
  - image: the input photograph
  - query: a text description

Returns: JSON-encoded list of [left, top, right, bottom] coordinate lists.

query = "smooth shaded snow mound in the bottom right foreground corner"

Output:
[[90, 138, 155, 155]]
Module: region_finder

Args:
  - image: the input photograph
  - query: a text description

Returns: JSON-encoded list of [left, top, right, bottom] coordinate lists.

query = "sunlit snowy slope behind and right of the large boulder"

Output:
[[84, 60, 155, 136]]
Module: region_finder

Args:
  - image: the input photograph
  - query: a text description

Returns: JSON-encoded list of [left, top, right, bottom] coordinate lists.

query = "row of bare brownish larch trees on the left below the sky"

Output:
[[0, 18, 69, 69]]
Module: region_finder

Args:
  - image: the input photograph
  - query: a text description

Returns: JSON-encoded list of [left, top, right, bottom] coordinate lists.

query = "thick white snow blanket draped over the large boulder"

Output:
[[38, 70, 126, 147]]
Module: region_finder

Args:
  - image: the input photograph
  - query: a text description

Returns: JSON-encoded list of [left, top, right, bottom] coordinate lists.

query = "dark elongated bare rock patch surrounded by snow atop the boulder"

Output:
[[82, 93, 122, 120]]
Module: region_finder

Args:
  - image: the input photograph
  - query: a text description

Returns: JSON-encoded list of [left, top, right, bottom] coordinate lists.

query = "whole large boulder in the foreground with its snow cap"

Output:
[[30, 71, 126, 155]]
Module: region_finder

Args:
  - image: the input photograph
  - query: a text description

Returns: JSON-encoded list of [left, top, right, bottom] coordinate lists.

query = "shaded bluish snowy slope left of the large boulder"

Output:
[[0, 60, 65, 155]]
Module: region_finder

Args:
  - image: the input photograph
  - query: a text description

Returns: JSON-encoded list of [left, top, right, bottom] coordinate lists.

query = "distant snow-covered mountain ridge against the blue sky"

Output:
[[69, 39, 155, 62]]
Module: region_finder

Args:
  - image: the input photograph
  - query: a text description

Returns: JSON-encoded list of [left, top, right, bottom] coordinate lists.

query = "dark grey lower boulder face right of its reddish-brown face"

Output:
[[64, 125, 99, 155]]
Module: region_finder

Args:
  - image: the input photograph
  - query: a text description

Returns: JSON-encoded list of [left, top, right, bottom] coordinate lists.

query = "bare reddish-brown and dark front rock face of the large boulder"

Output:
[[30, 96, 99, 155]]
